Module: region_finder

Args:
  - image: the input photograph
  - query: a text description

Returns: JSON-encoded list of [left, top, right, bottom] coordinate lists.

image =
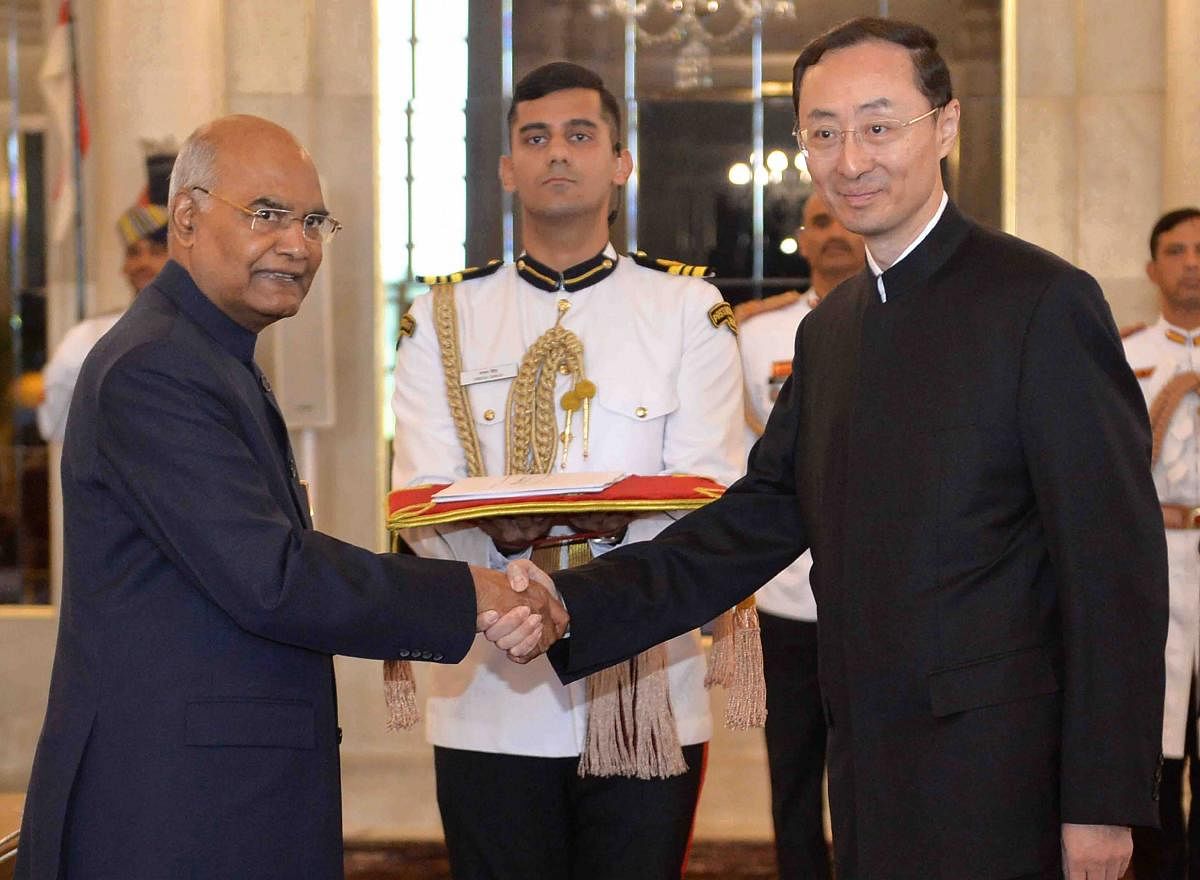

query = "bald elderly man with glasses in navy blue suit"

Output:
[[17, 116, 565, 880]]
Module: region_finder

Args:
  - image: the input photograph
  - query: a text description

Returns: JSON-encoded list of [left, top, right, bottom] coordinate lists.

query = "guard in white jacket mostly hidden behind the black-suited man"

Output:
[[738, 192, 864, 880]]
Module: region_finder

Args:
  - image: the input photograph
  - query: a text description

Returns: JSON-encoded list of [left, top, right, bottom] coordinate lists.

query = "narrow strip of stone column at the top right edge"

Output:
[[1162, 0, 1200, 211]]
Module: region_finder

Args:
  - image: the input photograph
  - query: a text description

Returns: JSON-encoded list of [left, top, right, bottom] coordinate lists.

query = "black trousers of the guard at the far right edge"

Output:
[[1133, 681, 1200, 880]]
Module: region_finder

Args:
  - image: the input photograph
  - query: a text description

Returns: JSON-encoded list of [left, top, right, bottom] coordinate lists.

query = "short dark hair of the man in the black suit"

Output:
[[792, 16, 954, 118]]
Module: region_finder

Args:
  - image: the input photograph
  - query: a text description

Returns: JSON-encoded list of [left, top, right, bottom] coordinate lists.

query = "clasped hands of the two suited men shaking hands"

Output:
[[470, 559, 571, 663]]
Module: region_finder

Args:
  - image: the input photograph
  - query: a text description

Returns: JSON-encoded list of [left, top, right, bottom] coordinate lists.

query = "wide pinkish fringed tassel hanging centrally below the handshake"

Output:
[[578, 645, 688, 779]]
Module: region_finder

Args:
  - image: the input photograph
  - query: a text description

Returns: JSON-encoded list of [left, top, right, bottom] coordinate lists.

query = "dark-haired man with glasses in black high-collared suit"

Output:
[[488, 19, 1166, 880]]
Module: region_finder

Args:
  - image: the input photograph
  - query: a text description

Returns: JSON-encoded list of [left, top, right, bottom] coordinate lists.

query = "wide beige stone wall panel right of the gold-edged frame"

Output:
[[1016, 0, 1161, 323]]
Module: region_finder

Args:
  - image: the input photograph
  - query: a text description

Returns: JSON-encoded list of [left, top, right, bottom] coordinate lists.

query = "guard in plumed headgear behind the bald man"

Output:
[[37, 151, 175, 443]]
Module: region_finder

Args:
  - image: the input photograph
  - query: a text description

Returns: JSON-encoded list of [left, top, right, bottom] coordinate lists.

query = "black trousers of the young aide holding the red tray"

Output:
[[433, 744, 708, 880]]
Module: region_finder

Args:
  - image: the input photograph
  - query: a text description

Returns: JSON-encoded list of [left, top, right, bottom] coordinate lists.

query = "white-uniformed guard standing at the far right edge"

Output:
[[1122, 208, 1200, 878]]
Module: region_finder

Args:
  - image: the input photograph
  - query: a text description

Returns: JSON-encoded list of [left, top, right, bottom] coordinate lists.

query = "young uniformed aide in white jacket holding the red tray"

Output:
[[392, 62, 745, 880]]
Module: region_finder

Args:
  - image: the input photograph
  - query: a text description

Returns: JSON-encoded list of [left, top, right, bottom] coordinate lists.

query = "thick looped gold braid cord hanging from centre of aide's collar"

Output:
[[505, 306, 585, 474]]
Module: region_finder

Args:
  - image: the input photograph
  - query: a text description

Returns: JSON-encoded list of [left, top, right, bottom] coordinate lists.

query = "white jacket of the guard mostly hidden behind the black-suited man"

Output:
[[738, 293, 817, 621]]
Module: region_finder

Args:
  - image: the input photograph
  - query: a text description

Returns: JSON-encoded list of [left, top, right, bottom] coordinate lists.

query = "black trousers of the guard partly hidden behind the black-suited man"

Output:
[[758, 612, 829, 880]]
